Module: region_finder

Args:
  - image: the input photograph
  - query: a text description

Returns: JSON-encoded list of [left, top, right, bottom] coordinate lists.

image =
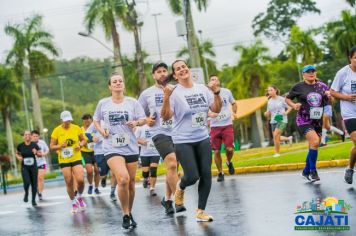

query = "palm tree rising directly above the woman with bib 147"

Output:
[[84, 0, 127, 77]]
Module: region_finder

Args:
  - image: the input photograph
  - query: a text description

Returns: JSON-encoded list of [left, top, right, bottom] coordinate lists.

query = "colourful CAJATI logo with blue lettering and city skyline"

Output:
[[294, 197, 352, 231]]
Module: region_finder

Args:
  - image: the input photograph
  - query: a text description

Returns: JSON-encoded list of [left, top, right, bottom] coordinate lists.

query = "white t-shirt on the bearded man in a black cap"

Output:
[[138, 85, 173, 137]]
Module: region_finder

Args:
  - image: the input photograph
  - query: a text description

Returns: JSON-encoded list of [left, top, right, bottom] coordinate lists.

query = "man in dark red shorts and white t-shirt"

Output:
[[209, 75, 237, 182]]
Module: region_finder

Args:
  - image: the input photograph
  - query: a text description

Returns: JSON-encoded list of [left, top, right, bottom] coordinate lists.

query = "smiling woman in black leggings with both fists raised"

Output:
[[161, 60, 222, 221]]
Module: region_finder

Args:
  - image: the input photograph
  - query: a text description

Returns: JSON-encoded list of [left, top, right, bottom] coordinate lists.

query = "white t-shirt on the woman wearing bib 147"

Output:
[[93, 97, 145, 155]]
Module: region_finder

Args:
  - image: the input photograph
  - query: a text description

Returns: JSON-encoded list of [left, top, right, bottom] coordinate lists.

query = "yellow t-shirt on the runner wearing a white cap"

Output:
[[51, 124, 83, 164]]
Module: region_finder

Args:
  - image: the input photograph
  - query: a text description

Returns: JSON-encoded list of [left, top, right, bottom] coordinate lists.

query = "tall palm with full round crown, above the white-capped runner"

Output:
[[5, 15, 58, 132]]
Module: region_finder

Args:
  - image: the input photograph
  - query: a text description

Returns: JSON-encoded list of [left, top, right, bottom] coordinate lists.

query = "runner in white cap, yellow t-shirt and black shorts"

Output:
[[50, 111, 86, 213]]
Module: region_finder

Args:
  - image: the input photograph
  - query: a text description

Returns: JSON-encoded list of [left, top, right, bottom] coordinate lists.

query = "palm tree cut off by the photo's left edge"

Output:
[[0, 65, 21, 174]]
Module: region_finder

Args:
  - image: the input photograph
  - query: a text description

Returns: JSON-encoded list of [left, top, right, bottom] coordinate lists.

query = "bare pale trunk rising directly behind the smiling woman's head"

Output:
[[183, 0, 201, 68]]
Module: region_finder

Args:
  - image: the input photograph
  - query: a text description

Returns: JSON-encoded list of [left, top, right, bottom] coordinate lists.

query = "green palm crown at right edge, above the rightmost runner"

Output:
[[327, 11, 356, 56]]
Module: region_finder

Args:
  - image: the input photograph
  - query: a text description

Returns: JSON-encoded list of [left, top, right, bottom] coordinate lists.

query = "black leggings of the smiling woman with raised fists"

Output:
[[175, 138, 212, 210]]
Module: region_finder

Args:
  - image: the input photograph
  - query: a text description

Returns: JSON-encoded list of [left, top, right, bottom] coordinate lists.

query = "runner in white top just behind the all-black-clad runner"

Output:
[[31, 130, 49, 200]]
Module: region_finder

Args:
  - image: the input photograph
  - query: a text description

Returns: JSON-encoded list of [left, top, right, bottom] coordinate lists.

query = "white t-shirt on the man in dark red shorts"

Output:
[[210, 88, 235, 127]]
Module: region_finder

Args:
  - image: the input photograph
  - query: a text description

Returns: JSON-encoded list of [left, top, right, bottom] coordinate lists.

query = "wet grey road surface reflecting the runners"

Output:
[[0, 168, 356, 236]]
